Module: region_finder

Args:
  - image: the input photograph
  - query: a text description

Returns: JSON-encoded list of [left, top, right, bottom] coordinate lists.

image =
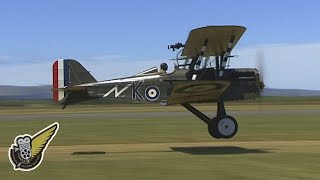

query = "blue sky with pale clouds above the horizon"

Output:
[[0, 0, 320, 90]]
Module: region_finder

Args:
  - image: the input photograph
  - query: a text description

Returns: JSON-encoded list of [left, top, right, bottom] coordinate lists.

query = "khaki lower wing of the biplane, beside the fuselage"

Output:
[[168, 81, 230, 104]]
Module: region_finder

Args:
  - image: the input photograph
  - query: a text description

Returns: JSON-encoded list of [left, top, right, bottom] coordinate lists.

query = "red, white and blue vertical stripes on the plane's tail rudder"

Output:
[[52, 59, 70, 102]]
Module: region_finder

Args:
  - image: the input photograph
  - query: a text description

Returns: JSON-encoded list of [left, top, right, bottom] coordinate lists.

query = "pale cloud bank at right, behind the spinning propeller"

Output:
[[231, 43, 320, 90]]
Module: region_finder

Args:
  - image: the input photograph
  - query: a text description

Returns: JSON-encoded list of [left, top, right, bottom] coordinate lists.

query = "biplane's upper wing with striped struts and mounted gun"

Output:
[[168, 26, 245, 80]]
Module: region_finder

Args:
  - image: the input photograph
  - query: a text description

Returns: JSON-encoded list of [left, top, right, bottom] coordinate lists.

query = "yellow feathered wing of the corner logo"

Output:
[[31, 123, 58, 156]]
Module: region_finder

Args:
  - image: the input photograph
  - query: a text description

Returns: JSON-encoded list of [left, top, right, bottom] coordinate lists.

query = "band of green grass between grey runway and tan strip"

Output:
[[0, 114, 320, 147]]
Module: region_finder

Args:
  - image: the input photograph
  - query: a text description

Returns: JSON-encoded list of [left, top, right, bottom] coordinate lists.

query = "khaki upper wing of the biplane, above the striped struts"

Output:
[[182, 26, 246, 58]]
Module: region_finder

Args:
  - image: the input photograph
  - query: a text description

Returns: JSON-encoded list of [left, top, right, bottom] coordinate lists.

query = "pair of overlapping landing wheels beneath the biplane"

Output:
[[208, 116, 238, 139]]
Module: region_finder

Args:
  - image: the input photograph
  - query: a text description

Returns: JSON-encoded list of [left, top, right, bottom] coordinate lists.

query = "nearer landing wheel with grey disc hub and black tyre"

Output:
[[217, 116, 238, 139]]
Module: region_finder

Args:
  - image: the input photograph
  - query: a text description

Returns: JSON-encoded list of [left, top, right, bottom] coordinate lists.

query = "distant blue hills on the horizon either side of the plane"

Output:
[[0, 85, 320, 100]]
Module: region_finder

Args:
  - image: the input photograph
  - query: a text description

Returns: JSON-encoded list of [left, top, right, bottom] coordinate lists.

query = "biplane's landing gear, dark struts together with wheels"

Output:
[[181, 101, 238, 139]]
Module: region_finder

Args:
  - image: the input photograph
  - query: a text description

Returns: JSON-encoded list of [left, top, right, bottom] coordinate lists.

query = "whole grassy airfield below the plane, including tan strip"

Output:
[[0, 101, 320, 179]]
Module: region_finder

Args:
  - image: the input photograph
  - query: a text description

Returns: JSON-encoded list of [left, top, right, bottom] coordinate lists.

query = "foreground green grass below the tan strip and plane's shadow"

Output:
[[0, 152, 320, 179]]
